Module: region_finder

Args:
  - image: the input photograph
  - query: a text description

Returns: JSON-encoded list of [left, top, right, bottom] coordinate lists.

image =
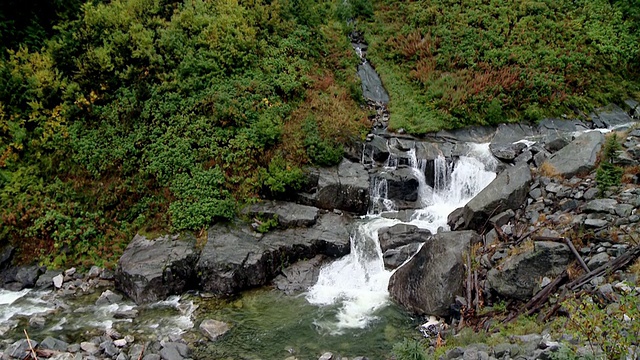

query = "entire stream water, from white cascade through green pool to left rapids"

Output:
[[0, 139, 496, 360]]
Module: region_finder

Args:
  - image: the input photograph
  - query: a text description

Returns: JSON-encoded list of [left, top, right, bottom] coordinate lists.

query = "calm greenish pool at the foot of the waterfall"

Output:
[[193, 290, 419, 360]]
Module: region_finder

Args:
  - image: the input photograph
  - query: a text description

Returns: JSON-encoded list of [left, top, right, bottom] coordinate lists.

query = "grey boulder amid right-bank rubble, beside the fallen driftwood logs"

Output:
[[487, 241, 571, 300]]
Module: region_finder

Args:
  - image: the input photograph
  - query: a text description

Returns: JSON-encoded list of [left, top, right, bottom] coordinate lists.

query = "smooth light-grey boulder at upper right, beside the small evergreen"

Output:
[[542, 131, 604, 178]]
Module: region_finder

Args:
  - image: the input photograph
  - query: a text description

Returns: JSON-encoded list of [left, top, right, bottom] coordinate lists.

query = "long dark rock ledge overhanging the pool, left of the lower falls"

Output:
[[196, 213, 349, 294]]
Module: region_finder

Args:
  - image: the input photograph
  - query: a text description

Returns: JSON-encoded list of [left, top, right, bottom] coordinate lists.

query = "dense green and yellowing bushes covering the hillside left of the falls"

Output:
[[0, 0, 366, 265]]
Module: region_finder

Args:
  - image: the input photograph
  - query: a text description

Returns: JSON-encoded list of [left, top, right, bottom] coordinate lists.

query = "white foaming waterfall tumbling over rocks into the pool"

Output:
[[307, 144, 497, 334]]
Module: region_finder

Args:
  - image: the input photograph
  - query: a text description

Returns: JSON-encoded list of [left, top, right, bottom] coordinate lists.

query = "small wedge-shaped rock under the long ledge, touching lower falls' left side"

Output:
[[273, 255, 327, 295]]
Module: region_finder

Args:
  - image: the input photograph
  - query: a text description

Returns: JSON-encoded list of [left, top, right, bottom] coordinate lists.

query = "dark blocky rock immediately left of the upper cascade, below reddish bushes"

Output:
[[298, 159, 369, 215]]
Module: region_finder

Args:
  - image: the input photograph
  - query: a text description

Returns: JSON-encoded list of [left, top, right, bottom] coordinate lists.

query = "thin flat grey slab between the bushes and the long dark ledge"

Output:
[[242, 201, 320, 228]]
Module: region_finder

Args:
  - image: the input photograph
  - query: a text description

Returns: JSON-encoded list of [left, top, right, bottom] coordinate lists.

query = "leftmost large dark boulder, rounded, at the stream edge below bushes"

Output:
[[115, 235, 198, 304]]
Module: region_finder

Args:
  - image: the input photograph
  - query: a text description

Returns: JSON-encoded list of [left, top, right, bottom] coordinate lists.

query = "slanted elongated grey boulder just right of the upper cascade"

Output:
[[448, 163, 532, 230]]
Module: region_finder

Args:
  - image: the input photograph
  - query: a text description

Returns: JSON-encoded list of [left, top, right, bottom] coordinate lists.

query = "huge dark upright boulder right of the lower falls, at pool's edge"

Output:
[[389, 231, 481, 316]]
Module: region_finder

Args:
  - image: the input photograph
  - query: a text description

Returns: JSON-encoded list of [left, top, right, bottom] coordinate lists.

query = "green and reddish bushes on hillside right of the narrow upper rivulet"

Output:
[[364, 0, 640, 133]]
